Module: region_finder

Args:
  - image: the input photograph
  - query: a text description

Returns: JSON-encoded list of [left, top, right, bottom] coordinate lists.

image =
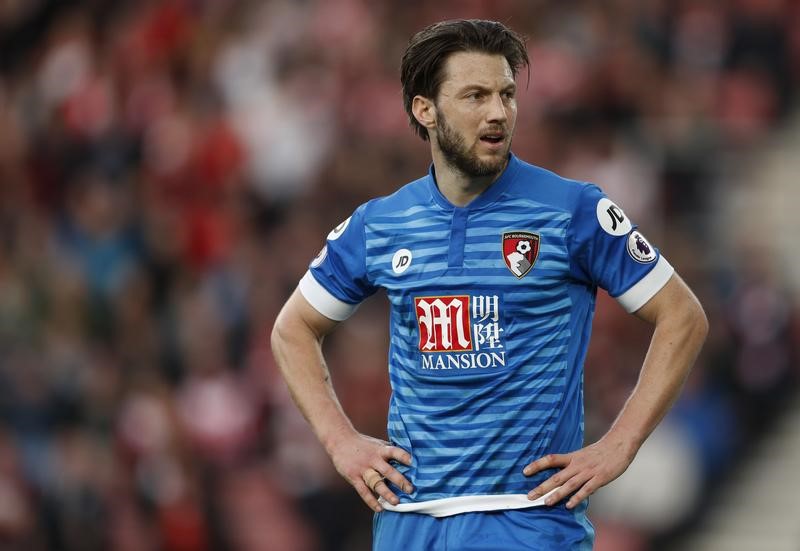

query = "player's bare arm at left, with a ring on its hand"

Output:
[[272, 290, 412, 511]]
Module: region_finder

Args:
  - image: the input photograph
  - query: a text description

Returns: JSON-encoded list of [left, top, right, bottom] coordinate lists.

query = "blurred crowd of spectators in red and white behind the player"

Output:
[[0, 0, 800, 551]]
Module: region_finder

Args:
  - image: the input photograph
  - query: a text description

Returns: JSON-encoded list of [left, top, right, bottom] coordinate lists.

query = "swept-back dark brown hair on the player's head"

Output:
[[400, 19, 529, 140]]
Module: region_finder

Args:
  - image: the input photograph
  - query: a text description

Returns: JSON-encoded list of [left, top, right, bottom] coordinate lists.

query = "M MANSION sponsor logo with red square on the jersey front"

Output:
[[414, 295, 506, 369]]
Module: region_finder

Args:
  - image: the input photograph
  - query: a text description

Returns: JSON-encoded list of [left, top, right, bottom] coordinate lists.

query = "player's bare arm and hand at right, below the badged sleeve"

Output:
[[523, 274, 708, 509]]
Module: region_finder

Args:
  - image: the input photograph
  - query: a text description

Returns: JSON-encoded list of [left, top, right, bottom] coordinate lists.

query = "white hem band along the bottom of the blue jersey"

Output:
[[378, 486, 561, 518]]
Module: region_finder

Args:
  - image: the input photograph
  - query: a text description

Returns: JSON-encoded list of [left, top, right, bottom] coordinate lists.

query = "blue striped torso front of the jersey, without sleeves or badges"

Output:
[[364, 183, 572, 501]]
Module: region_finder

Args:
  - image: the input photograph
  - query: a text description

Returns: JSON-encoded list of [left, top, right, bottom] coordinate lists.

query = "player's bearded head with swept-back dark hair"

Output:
[[401, 20, 528, 176]]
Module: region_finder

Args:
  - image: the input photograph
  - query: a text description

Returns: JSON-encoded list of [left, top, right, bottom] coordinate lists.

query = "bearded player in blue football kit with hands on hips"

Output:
[[272, 20, 707, 551]]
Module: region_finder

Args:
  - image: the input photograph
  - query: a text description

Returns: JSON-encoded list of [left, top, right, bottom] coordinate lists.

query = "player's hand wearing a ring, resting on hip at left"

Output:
[[328, 432, 414, 513]]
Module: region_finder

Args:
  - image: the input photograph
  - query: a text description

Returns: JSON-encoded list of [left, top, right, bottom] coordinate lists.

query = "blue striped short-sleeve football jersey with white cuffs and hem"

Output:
[[300, 155, 673, 514]]
